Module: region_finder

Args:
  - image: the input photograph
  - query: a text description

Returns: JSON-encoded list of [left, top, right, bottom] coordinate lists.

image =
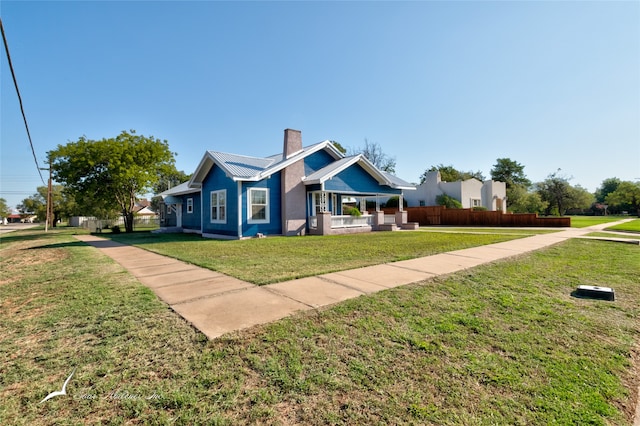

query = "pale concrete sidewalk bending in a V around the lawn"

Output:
[[75, 220, 638, 339]]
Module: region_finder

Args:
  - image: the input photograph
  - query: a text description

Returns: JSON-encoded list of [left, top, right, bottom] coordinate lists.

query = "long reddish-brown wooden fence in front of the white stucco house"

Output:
[[383, 206, 571, 227]]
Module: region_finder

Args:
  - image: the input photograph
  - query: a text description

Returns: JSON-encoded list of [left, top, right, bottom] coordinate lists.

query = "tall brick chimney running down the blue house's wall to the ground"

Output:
[[281, 129, 307, 235]]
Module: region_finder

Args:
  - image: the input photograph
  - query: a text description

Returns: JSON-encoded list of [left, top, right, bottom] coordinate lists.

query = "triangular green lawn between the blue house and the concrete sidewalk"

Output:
[[103, 232, 522, 285]]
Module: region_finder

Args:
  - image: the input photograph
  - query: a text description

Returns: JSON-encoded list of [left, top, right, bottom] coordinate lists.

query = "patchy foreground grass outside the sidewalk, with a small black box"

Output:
[[0, 232, 640, 425]]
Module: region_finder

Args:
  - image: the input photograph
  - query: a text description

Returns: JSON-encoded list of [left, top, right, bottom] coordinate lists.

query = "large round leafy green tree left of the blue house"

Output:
[[49, 130, 175, 232]]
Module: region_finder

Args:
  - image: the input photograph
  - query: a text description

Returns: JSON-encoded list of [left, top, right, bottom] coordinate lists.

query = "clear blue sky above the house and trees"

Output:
[[0, 0, 640, 210]]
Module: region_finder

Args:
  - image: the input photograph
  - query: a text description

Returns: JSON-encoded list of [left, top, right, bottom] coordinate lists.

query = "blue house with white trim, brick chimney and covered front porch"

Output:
[[158, 129, 415, 239]]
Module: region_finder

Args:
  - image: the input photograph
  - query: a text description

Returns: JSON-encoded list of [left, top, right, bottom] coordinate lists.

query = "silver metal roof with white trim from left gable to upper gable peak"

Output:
[[189, 140, 343, 188]]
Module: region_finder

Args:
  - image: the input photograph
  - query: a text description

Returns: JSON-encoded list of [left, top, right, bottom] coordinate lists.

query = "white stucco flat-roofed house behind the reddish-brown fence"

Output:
[[405, 171, 507, 213]]
